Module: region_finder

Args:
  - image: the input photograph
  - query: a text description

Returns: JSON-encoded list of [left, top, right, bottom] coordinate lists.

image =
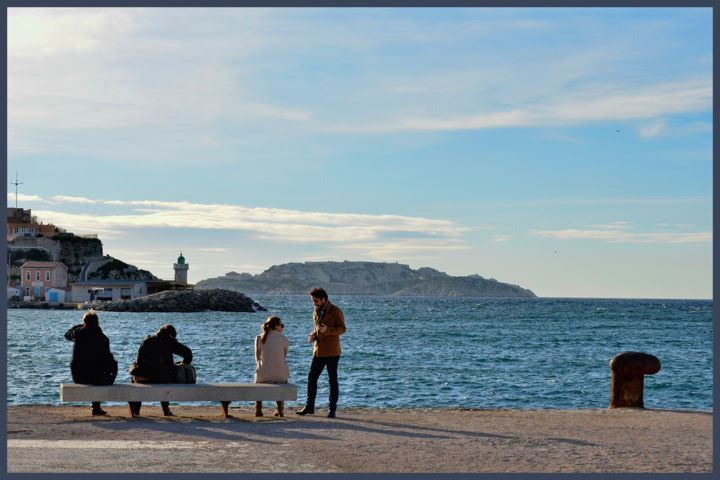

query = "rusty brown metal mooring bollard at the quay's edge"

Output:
[[610, 352, 660, 408]]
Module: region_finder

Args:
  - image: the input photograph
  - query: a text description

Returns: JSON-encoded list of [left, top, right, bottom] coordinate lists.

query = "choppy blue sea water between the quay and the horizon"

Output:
[[7, 295, 713, 409]]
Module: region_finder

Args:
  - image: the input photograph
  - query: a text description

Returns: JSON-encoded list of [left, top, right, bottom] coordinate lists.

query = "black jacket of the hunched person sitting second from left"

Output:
[[130, 332, 192, 383]]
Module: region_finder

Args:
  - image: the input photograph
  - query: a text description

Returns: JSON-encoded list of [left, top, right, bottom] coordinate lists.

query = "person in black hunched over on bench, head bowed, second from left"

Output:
[[130, 324, 192, 416]]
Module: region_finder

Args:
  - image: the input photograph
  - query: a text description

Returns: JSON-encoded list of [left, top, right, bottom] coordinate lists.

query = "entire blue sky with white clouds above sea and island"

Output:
[[6, 8, 713, 299]]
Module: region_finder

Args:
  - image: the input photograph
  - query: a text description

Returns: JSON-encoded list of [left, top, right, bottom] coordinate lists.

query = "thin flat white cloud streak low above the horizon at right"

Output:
[[531, 228, 712, 244]]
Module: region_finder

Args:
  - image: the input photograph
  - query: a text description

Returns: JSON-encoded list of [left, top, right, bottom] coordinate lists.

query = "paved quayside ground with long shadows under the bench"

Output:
[[7, 402, 713, 473]]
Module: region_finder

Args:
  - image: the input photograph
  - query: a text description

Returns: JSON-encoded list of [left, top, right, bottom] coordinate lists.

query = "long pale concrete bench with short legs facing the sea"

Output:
[[60, 383, 297, 418]]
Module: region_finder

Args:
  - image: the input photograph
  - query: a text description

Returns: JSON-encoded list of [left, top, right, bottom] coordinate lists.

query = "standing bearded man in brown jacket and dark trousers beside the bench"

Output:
[[295, 287, 345, 418]]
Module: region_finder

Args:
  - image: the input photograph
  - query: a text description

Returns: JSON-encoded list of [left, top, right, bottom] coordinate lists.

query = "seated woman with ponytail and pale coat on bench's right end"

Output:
[[255, 317, 290, 417]]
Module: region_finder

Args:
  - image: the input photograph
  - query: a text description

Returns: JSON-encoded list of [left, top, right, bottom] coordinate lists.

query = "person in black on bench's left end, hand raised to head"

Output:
[[65, 311, 117, 415]]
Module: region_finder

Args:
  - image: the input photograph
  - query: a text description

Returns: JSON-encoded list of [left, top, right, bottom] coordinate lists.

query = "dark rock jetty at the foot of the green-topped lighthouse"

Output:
[[93, 288, 266, 312]]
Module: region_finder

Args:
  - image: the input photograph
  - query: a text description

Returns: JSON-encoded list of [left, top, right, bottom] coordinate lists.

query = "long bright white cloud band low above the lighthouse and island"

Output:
[[35, 196, 468, 248]]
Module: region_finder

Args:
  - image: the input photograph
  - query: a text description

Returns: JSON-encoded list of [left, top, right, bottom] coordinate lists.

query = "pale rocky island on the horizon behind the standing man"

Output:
[[195, 261, 536, 297]]
